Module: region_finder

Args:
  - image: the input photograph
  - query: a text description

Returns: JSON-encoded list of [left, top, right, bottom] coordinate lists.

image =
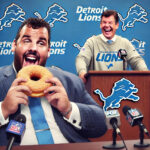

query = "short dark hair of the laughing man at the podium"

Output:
[[101, 10, 119, 24]]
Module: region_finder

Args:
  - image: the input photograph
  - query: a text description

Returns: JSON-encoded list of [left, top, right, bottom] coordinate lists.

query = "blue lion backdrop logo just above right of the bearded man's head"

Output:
[[34, 4, 68, 27]]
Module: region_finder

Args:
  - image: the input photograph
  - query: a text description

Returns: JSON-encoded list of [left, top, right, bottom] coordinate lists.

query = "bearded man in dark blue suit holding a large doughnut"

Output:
[[0, 18, 107, 145]]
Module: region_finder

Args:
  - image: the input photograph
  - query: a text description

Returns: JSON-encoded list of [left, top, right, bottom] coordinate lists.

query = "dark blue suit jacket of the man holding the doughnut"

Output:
[[0, 65, 107, 145]]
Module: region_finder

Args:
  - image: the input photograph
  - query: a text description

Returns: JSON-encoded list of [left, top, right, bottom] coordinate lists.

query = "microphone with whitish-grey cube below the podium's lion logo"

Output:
[[105, 110, 120, 134]]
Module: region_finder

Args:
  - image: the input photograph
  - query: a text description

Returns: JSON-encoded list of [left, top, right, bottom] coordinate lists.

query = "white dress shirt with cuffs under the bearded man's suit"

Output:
[[0, 97, 81, 145]]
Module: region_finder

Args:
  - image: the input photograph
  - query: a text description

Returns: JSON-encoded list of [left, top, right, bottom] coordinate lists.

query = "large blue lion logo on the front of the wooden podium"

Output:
[[94, 78, 139, 111]]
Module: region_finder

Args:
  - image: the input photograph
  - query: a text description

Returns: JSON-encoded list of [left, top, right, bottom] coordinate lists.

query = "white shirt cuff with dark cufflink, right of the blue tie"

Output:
[[64, 102, 81, 129]]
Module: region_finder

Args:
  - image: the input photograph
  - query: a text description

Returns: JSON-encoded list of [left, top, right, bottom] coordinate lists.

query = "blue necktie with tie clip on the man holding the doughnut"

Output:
[[29, 97, 54, 144]]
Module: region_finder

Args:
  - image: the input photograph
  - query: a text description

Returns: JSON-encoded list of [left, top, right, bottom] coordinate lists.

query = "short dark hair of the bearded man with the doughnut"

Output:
[[15, 18, 51, 46]]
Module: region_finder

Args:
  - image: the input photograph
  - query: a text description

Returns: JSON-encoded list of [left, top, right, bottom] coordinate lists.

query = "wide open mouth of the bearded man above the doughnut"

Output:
[[23, 51, 40, 66]]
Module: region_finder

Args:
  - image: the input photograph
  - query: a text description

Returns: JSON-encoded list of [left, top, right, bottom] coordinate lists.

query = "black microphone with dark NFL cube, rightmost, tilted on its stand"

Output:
[[122, 106, 149, 136]]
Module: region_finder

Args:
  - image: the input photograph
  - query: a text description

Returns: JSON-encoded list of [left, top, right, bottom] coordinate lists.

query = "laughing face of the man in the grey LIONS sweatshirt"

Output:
[[100, 15, 119, 39]]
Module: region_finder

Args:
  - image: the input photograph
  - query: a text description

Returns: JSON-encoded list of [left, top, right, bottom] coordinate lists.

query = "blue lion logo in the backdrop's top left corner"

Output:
[[0, 3, 25, 30]]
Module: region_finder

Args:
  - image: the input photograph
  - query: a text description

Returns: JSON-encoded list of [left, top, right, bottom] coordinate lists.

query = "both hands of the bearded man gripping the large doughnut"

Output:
[[2, 69, 71, 119]]
